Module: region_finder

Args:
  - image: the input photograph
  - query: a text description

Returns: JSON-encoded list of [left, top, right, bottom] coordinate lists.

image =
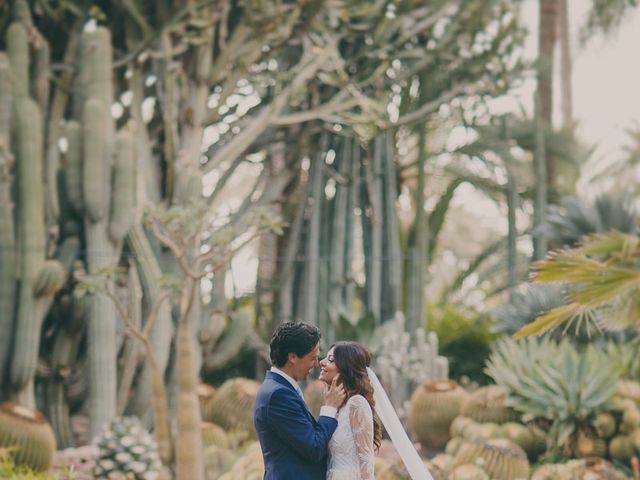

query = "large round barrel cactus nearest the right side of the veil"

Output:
[[409, 380, 467, 448]]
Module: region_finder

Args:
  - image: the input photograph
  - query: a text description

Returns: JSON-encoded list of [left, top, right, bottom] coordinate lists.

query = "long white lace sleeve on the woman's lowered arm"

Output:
[[348, 395, 374, 480]]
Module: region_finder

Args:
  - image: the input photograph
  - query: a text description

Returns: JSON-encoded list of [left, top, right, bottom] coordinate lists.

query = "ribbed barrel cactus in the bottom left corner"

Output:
[[0, 402, 56, 471]]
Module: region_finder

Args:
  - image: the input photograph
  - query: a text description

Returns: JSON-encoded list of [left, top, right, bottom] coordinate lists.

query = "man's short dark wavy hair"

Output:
[[270, 322, 321, 367]]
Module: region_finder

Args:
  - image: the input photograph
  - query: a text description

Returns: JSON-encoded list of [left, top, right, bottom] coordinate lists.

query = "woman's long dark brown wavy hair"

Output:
[[330, 342, 382, 450]]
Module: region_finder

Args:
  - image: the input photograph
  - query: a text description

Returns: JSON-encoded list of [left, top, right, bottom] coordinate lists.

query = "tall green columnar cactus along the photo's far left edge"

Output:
[[0, 5, 64, 407]]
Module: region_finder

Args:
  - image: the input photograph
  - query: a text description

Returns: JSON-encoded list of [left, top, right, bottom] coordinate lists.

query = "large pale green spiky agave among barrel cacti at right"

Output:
[[486, 338, 619, 451]]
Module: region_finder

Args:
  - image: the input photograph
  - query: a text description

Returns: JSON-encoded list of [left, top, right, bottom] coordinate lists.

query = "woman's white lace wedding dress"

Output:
[[327, 395, 375, 480]]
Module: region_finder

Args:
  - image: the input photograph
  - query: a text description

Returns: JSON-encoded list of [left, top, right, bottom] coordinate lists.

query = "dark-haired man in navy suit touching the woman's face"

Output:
[[253, 322, 345, 480]]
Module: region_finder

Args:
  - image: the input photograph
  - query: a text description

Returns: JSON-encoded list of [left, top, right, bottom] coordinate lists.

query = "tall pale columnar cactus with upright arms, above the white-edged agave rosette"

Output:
[[72, 27, 135, 433]]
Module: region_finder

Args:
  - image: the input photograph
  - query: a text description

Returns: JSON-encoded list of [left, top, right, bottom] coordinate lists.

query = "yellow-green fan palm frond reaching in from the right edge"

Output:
[[515, 231, 640, 338]]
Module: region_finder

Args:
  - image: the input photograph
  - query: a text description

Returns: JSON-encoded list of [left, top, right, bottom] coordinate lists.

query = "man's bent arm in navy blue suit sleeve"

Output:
[[267, 389, 338, 463]]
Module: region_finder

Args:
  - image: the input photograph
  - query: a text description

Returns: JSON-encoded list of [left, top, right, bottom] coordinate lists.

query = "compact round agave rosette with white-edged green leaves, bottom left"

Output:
[[93, 417, 160, 480]]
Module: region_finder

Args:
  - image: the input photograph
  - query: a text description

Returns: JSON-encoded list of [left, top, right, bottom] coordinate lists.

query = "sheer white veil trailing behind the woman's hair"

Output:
[[367, 367, 433, 480]]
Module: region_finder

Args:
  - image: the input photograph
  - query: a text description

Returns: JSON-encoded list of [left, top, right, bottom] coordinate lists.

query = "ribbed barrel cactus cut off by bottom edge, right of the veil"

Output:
[[453, 438, 530, 480]]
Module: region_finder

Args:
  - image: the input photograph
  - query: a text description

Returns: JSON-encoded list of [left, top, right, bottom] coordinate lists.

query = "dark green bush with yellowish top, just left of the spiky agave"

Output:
[[428, 305, 498, 384]]
